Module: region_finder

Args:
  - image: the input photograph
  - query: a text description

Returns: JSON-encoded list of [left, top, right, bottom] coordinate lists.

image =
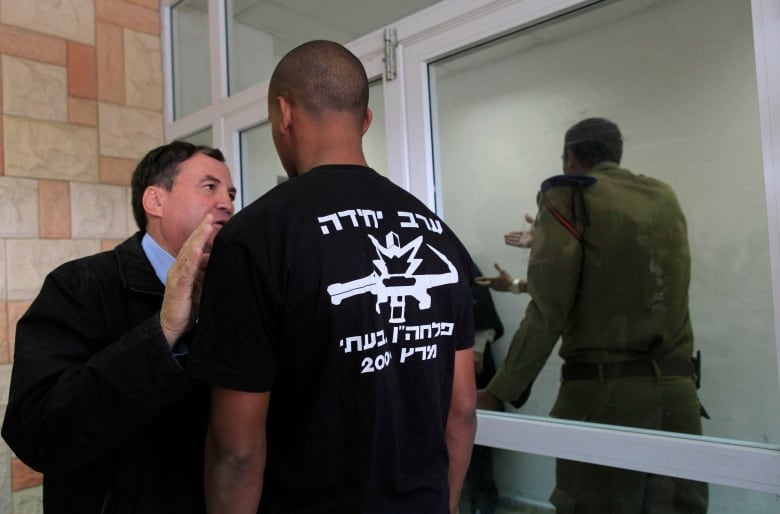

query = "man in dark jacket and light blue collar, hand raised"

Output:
[[2, 141, 235, 514]]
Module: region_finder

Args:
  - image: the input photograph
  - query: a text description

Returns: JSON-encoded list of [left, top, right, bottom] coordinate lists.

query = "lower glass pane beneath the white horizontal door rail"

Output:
[[459, 446, 780, 514]]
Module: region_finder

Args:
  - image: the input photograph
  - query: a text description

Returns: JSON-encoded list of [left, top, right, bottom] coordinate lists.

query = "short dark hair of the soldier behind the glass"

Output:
[[563, 118, 623, 169]]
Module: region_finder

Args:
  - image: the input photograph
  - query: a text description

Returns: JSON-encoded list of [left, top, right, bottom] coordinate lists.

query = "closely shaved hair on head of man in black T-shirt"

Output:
[[268, 41, 368, 124]]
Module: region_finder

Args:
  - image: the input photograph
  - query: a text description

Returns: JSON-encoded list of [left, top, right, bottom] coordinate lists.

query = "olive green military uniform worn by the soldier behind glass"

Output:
[[487, 162, 707, 514]]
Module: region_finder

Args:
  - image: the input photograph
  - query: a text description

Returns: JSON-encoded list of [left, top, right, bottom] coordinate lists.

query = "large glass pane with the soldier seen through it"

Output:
[[430, 0, 780, 444]]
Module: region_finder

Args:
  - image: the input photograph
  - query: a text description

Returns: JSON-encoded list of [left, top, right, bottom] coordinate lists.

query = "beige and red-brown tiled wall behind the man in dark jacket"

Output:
[[0, 0, 163, 508]]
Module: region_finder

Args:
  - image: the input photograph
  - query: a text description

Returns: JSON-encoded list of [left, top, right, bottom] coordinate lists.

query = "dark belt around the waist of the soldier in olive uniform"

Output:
[[561, 358, 694, 381]]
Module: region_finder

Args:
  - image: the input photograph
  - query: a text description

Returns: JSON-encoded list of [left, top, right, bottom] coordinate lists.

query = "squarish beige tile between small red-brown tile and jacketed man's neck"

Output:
[[70, 182, 127, 239]]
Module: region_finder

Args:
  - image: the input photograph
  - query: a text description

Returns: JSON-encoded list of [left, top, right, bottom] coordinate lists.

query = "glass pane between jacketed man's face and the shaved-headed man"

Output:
[[241, 123, 287, 205]]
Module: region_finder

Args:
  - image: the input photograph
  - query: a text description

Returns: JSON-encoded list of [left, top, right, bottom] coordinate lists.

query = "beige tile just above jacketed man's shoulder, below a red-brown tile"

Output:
[[5, 239, 100, 300]]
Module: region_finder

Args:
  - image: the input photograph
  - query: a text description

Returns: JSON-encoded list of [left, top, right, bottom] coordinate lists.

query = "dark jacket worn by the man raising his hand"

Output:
[[2, 233, 207, 514]]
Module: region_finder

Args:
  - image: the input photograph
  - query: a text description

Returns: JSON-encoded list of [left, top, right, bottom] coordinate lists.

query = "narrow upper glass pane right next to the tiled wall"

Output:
[[171, 0, 211, 119]]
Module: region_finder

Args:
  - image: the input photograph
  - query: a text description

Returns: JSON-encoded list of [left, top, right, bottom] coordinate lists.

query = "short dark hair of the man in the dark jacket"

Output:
[[130, 141, 225, 232]]
